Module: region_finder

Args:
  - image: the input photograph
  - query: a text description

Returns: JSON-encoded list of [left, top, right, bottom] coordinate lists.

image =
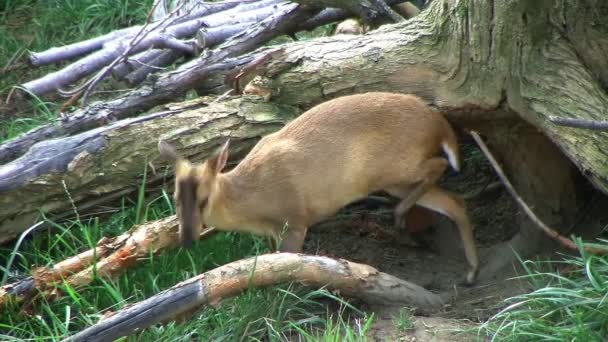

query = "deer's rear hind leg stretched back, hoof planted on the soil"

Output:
[[416, 187, 479, 285]]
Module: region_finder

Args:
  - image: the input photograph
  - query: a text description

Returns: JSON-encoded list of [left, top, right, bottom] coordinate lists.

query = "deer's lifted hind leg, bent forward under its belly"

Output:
[[386, 157, 448, 230]]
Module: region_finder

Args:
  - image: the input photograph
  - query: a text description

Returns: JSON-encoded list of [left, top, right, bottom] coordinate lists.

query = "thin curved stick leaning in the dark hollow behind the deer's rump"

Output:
[[469, 131, 608, 255]]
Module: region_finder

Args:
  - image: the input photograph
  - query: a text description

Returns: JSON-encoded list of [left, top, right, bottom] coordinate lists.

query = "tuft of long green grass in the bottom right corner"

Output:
[[481, 242, 608, 341]]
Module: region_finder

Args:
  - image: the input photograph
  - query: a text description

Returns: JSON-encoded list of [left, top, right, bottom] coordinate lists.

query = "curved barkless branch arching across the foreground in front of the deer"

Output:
[[64, 253, 442, 341]]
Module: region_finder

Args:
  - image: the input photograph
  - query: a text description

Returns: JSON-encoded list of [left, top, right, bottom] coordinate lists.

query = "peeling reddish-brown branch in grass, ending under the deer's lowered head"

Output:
[[0, 215, 215, 307]]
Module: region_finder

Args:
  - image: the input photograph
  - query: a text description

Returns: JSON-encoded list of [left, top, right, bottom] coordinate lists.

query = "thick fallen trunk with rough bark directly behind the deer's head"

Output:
[[0, 99, 298, 242]]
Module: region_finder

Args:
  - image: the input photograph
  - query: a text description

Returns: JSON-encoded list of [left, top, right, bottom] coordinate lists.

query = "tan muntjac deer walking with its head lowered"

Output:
[[159, 92, 479, 283]]
